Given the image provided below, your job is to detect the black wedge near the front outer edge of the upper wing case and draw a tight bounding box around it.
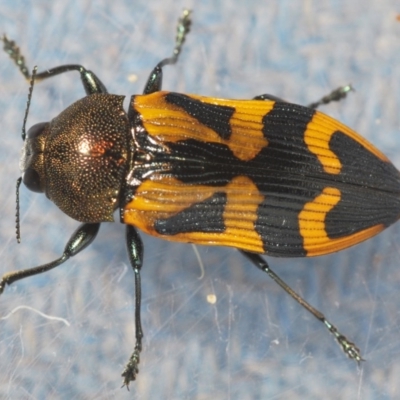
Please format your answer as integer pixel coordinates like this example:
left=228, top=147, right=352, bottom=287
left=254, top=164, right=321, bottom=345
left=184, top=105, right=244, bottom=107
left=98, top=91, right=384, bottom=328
left=165, top=92, right=235, bottom=140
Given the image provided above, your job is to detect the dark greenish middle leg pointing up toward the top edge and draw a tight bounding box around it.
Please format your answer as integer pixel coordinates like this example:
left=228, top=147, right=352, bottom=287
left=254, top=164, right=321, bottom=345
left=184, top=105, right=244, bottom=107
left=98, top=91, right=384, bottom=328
left=143, top=10, right=192, bottom=94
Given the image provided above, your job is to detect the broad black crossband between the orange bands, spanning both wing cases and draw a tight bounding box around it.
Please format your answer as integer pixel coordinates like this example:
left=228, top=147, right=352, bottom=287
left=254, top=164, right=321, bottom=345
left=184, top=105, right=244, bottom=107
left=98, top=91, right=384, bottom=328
left=254, top=102, right=318, bottom=257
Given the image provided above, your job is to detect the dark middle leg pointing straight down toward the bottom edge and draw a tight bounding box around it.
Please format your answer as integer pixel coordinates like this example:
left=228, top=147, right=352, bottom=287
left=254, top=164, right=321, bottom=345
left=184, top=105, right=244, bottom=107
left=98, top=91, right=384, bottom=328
left=121, top=225, right=143, bottom=389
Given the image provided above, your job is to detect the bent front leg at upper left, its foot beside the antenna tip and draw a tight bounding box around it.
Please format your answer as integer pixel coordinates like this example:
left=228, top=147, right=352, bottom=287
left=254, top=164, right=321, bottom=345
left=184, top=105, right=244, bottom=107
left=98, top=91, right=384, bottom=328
left=1, top=35, right=107, bottom=94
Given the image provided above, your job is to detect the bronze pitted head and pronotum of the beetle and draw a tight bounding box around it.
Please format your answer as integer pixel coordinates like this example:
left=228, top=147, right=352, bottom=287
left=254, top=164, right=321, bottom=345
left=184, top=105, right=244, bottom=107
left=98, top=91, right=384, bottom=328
left=20, top=94, right=130, bottom=222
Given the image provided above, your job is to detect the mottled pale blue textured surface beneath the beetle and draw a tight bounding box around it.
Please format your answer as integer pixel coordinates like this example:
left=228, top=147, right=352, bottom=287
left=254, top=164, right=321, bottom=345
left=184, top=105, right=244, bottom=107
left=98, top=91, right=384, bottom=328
left=0, top=0, right=400, bottom=400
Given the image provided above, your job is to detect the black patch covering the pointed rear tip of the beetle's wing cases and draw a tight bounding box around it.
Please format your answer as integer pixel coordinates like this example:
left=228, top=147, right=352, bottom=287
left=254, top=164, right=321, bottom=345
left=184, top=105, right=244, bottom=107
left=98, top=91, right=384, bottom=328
left=325, top=131, right=400, bottom=238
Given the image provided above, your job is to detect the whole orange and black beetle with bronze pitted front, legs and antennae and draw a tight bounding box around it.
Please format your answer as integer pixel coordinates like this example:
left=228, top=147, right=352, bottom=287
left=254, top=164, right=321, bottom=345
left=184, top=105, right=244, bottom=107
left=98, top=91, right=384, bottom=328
left=0, top=10, right=400, bottom=388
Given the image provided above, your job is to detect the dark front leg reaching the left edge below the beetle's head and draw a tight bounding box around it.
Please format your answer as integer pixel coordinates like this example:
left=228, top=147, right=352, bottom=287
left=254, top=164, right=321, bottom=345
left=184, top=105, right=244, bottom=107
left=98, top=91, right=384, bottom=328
left=0, top=224, right=100, bottom=294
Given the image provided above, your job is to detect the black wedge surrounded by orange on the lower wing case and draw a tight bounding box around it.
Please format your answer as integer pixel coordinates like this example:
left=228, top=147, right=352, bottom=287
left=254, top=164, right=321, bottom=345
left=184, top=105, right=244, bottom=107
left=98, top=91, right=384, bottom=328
left=154, top=192, right=227, bottom=235
